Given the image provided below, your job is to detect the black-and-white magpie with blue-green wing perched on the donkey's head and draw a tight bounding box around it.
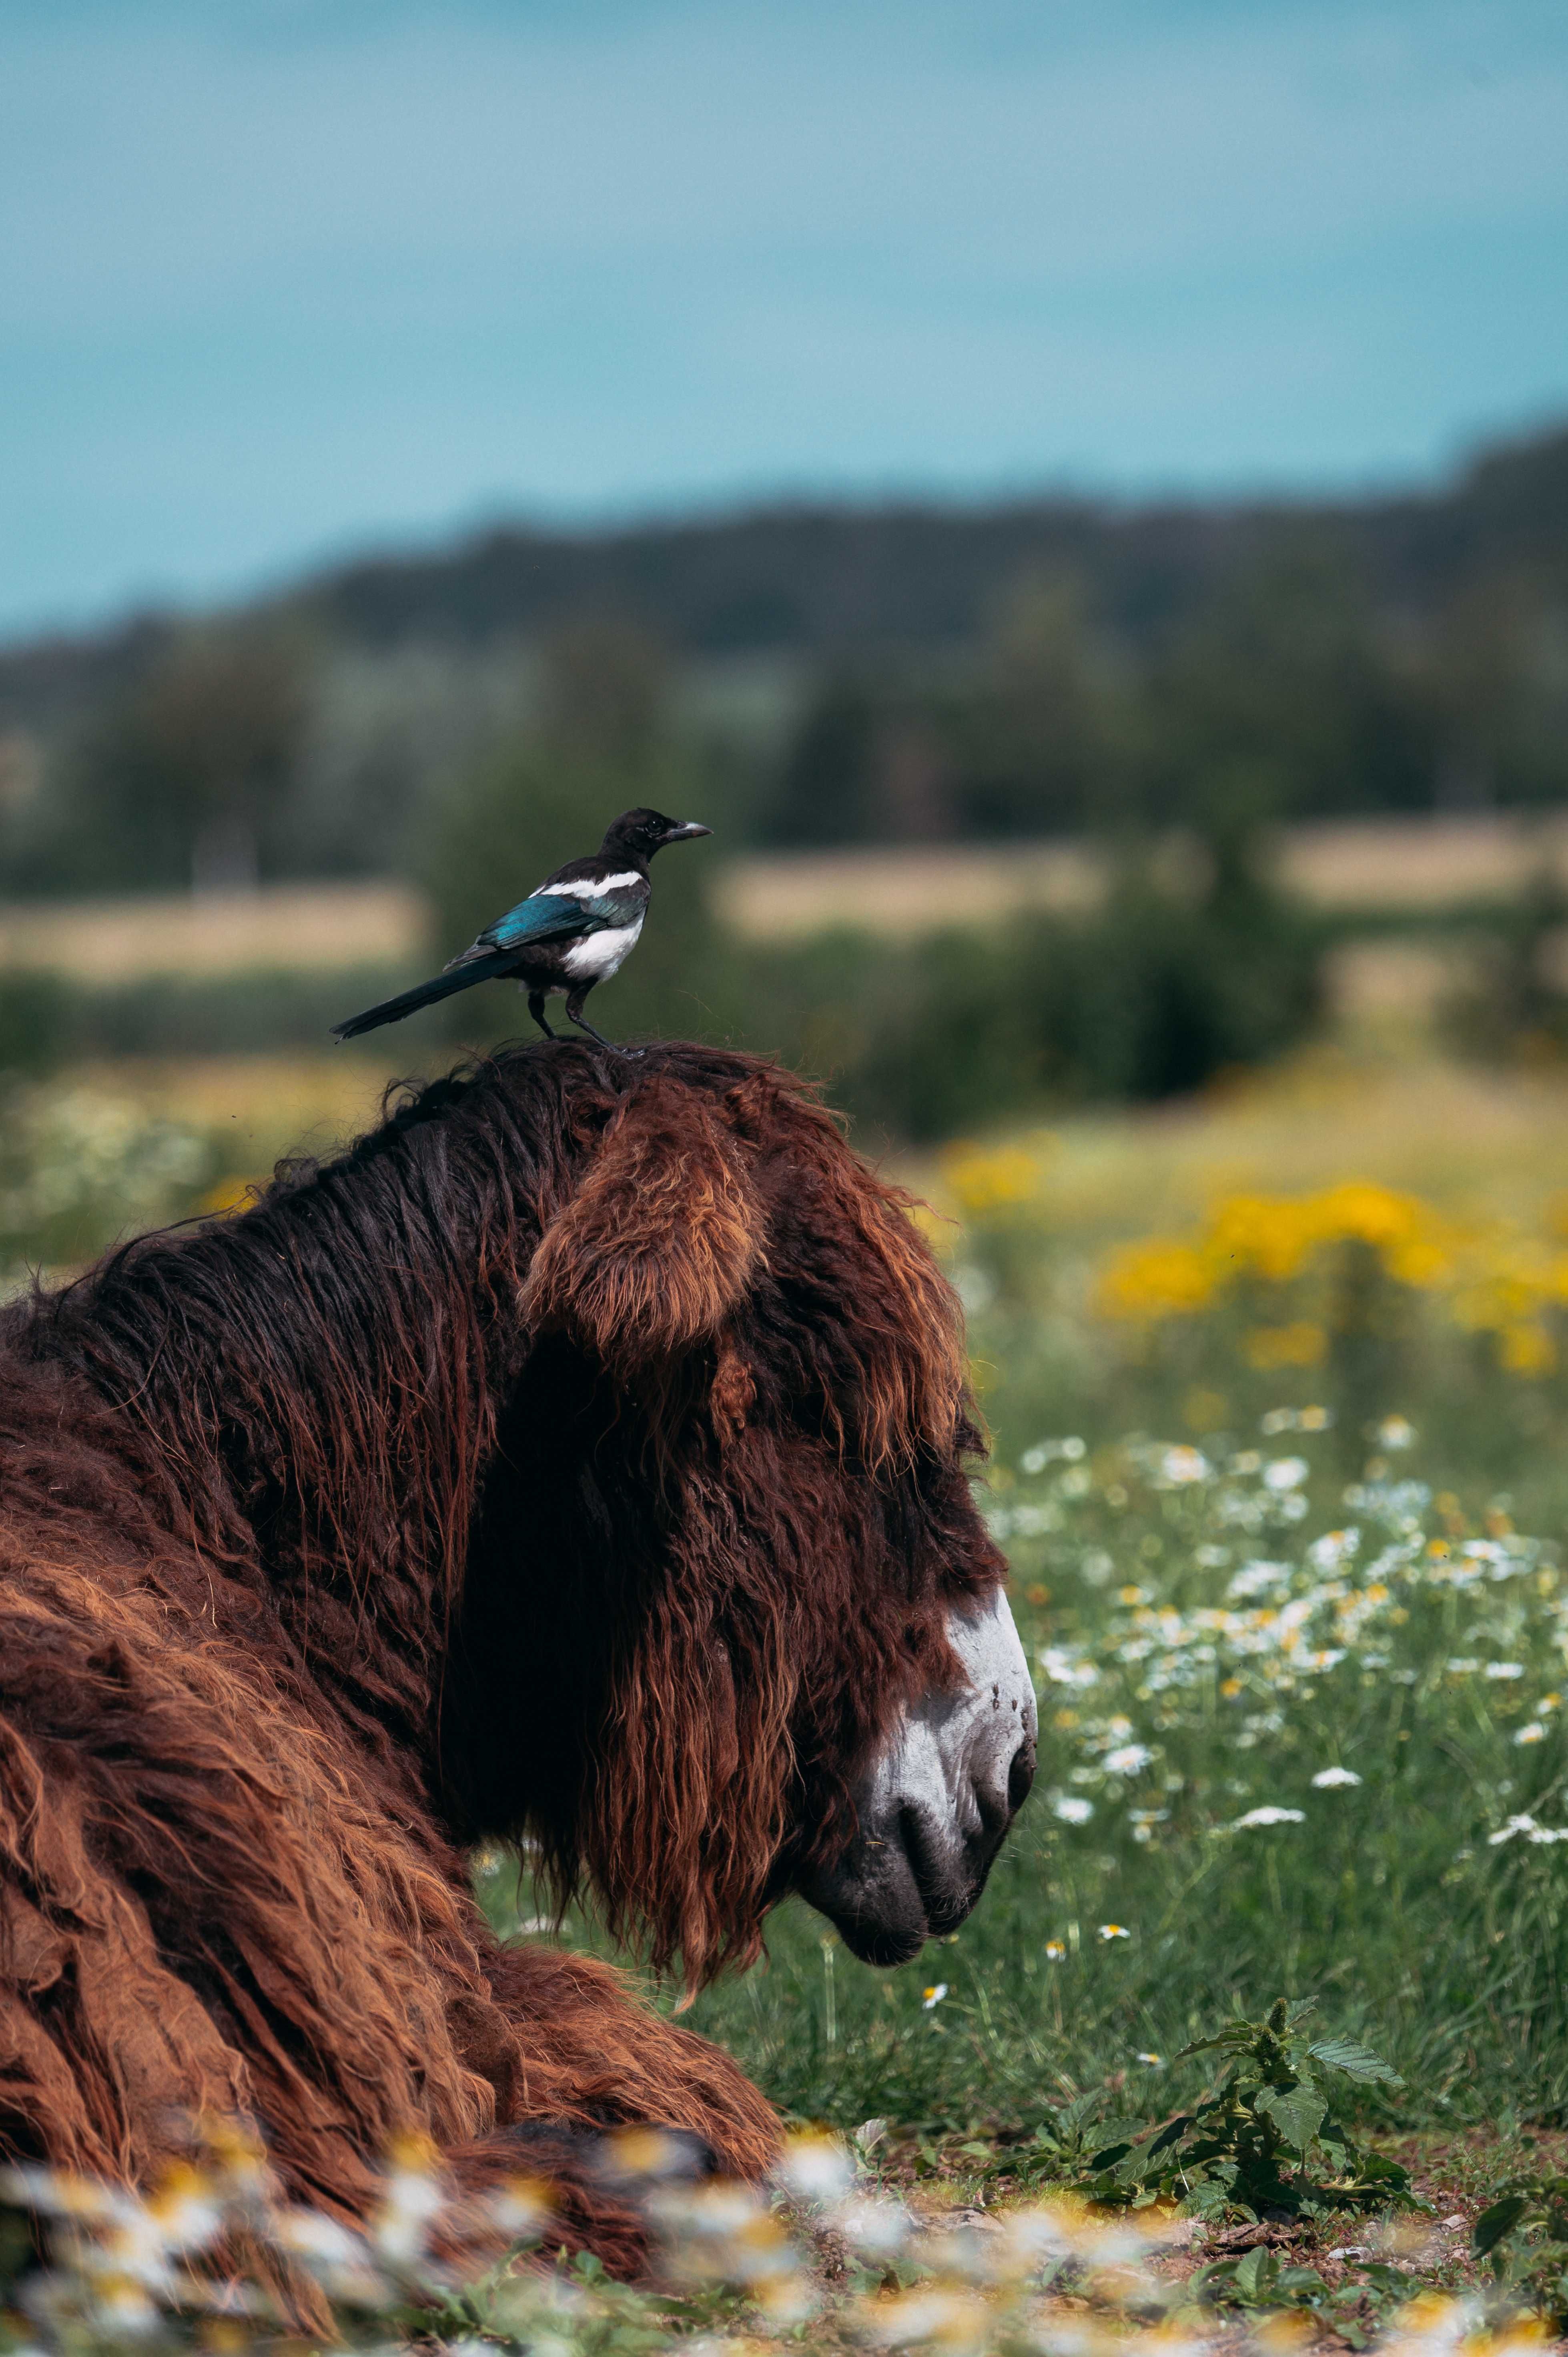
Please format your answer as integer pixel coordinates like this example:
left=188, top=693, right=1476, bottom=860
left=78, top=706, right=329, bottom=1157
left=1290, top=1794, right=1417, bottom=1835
left=333, top=811, right=712, bottom=1047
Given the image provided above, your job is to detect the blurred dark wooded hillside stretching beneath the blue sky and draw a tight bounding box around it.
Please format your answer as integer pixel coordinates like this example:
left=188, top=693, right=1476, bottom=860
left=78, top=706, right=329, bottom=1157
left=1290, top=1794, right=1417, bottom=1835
left=0, top=429, right=1568, bottom=898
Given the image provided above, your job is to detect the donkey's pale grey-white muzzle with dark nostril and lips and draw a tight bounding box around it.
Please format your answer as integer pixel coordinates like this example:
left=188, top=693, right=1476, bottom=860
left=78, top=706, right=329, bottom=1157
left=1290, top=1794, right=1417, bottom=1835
left=802, top=1589, right=1037, bottom=1964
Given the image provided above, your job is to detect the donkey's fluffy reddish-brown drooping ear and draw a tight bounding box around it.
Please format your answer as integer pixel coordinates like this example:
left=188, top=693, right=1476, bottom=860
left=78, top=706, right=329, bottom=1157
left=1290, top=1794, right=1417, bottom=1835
left=523, top=1075, right=764, bottom=1376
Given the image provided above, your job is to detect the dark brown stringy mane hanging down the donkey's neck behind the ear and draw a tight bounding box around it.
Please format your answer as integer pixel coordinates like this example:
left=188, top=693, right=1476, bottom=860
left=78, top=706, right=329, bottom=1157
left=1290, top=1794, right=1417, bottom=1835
left=0, top=1042, right=768, bottom=1763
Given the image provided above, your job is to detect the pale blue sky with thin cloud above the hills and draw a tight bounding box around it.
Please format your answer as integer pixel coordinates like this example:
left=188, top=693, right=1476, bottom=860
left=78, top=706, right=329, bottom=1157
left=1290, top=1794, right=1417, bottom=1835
left=0, top=0, right=1568, bottom=634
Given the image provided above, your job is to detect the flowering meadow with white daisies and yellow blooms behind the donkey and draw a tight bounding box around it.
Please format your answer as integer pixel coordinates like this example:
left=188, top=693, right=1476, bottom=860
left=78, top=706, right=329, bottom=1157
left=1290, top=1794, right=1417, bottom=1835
left=15, top=1032, right=1568, bottom=2345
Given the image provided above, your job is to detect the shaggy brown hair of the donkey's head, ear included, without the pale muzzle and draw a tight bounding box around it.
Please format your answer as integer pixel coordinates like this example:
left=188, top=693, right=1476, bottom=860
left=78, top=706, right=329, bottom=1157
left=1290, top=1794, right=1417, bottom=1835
left=511, top=1063, right=974, bottom=1985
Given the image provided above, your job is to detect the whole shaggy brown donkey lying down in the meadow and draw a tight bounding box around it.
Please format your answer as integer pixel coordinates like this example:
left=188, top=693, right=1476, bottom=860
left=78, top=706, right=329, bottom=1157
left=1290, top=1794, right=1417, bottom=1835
left=0, top=1044, right=1033, bottom=2270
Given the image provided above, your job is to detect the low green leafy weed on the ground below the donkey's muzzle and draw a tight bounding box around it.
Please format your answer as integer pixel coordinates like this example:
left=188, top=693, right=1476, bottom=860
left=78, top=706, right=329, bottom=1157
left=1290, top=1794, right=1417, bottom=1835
left=1028, top=1999, right=1415, bottom=2218
